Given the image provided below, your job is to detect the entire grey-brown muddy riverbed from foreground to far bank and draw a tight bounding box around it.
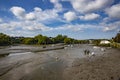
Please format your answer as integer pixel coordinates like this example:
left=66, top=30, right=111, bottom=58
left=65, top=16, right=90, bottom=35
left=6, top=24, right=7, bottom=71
left=0, top=45, right=120, bottom=80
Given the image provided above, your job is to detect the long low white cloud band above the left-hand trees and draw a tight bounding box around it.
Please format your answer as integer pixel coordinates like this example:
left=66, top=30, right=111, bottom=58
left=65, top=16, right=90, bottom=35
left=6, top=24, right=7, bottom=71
left=0, top=21, right=51, bottom=32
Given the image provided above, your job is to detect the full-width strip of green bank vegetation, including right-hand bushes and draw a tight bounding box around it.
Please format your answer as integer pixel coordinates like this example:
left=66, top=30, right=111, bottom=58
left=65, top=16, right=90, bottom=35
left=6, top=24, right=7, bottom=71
left=0, top=32, right=120, bottom=47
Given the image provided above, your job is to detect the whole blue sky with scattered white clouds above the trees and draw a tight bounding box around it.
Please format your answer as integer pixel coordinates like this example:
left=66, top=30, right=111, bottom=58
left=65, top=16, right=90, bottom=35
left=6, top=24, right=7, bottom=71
left=0, top=0, right=120, bottom=39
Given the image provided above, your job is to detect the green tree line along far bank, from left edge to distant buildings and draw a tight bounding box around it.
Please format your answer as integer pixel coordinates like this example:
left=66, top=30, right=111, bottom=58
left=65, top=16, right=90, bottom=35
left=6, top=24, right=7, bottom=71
left=0, top=33, right=89, bottom=46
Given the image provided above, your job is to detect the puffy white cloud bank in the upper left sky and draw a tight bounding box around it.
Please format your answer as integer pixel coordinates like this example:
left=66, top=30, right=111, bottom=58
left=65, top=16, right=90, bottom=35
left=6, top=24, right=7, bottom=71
left=10, top=6, right=58, bottom=21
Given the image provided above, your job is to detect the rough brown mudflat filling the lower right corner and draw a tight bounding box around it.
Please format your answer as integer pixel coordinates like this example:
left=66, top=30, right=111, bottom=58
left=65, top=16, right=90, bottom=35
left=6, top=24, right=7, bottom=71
left=64, top=49, right=120, bottom=80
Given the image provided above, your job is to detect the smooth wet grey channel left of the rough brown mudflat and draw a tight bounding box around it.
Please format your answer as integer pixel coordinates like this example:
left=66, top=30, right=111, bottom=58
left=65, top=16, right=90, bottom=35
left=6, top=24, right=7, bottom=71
left=0, top=45, right=103, bottom=80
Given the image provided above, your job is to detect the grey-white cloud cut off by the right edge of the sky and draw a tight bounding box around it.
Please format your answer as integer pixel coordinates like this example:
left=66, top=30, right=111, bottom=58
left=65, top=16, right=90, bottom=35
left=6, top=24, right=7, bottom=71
left=105, top=4, right=120, bottom=19
